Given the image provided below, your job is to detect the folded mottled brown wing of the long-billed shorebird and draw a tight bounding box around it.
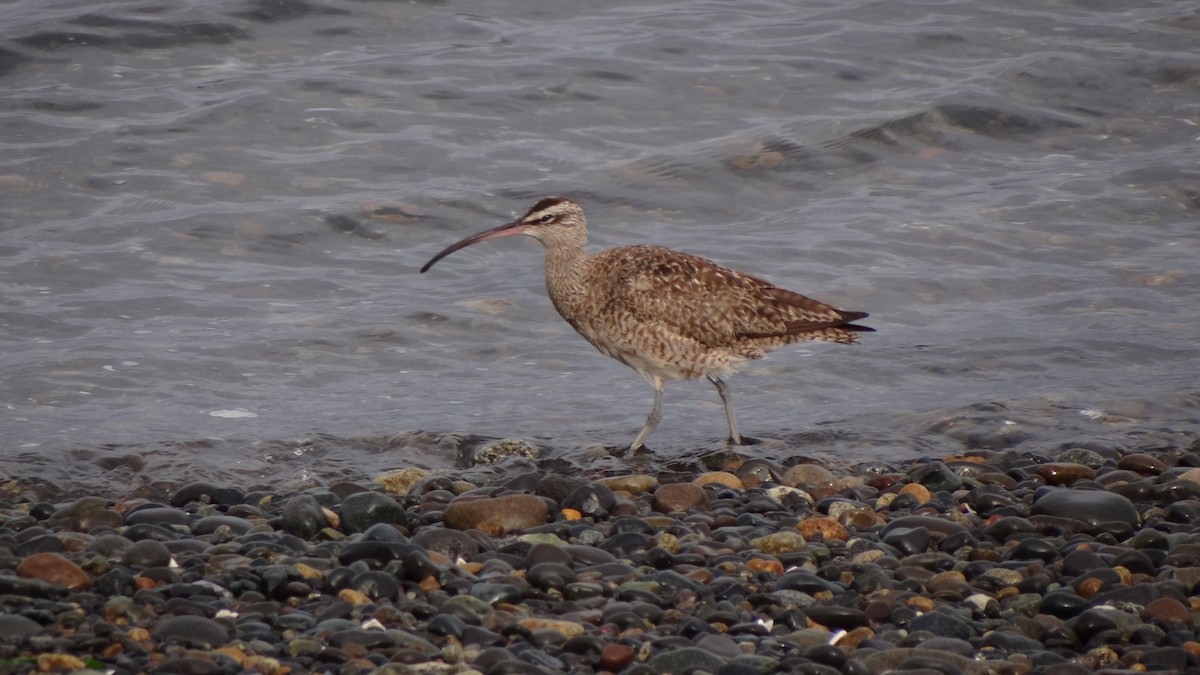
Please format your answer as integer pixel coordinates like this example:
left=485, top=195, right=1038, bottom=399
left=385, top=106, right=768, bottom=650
left=598, top=246, right=865, bottom=347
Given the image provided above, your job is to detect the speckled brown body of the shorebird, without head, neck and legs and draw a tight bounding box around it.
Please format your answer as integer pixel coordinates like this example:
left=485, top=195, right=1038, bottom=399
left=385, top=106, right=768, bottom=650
left=546, top=246, right=865, bottom=380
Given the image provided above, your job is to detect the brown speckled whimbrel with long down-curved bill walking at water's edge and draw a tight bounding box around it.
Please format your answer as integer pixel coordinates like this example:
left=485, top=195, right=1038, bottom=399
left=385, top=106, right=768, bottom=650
left=421, top=197, right=875, bottom=456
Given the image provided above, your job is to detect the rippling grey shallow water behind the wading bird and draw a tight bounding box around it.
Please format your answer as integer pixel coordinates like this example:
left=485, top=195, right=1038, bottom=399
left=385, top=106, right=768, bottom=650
left=0, top=0, right=1200, bottom=494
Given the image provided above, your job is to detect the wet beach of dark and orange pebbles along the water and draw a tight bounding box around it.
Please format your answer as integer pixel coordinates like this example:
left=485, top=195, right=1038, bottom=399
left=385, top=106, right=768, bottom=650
left=7, top=442, right=1200, bottom=675
